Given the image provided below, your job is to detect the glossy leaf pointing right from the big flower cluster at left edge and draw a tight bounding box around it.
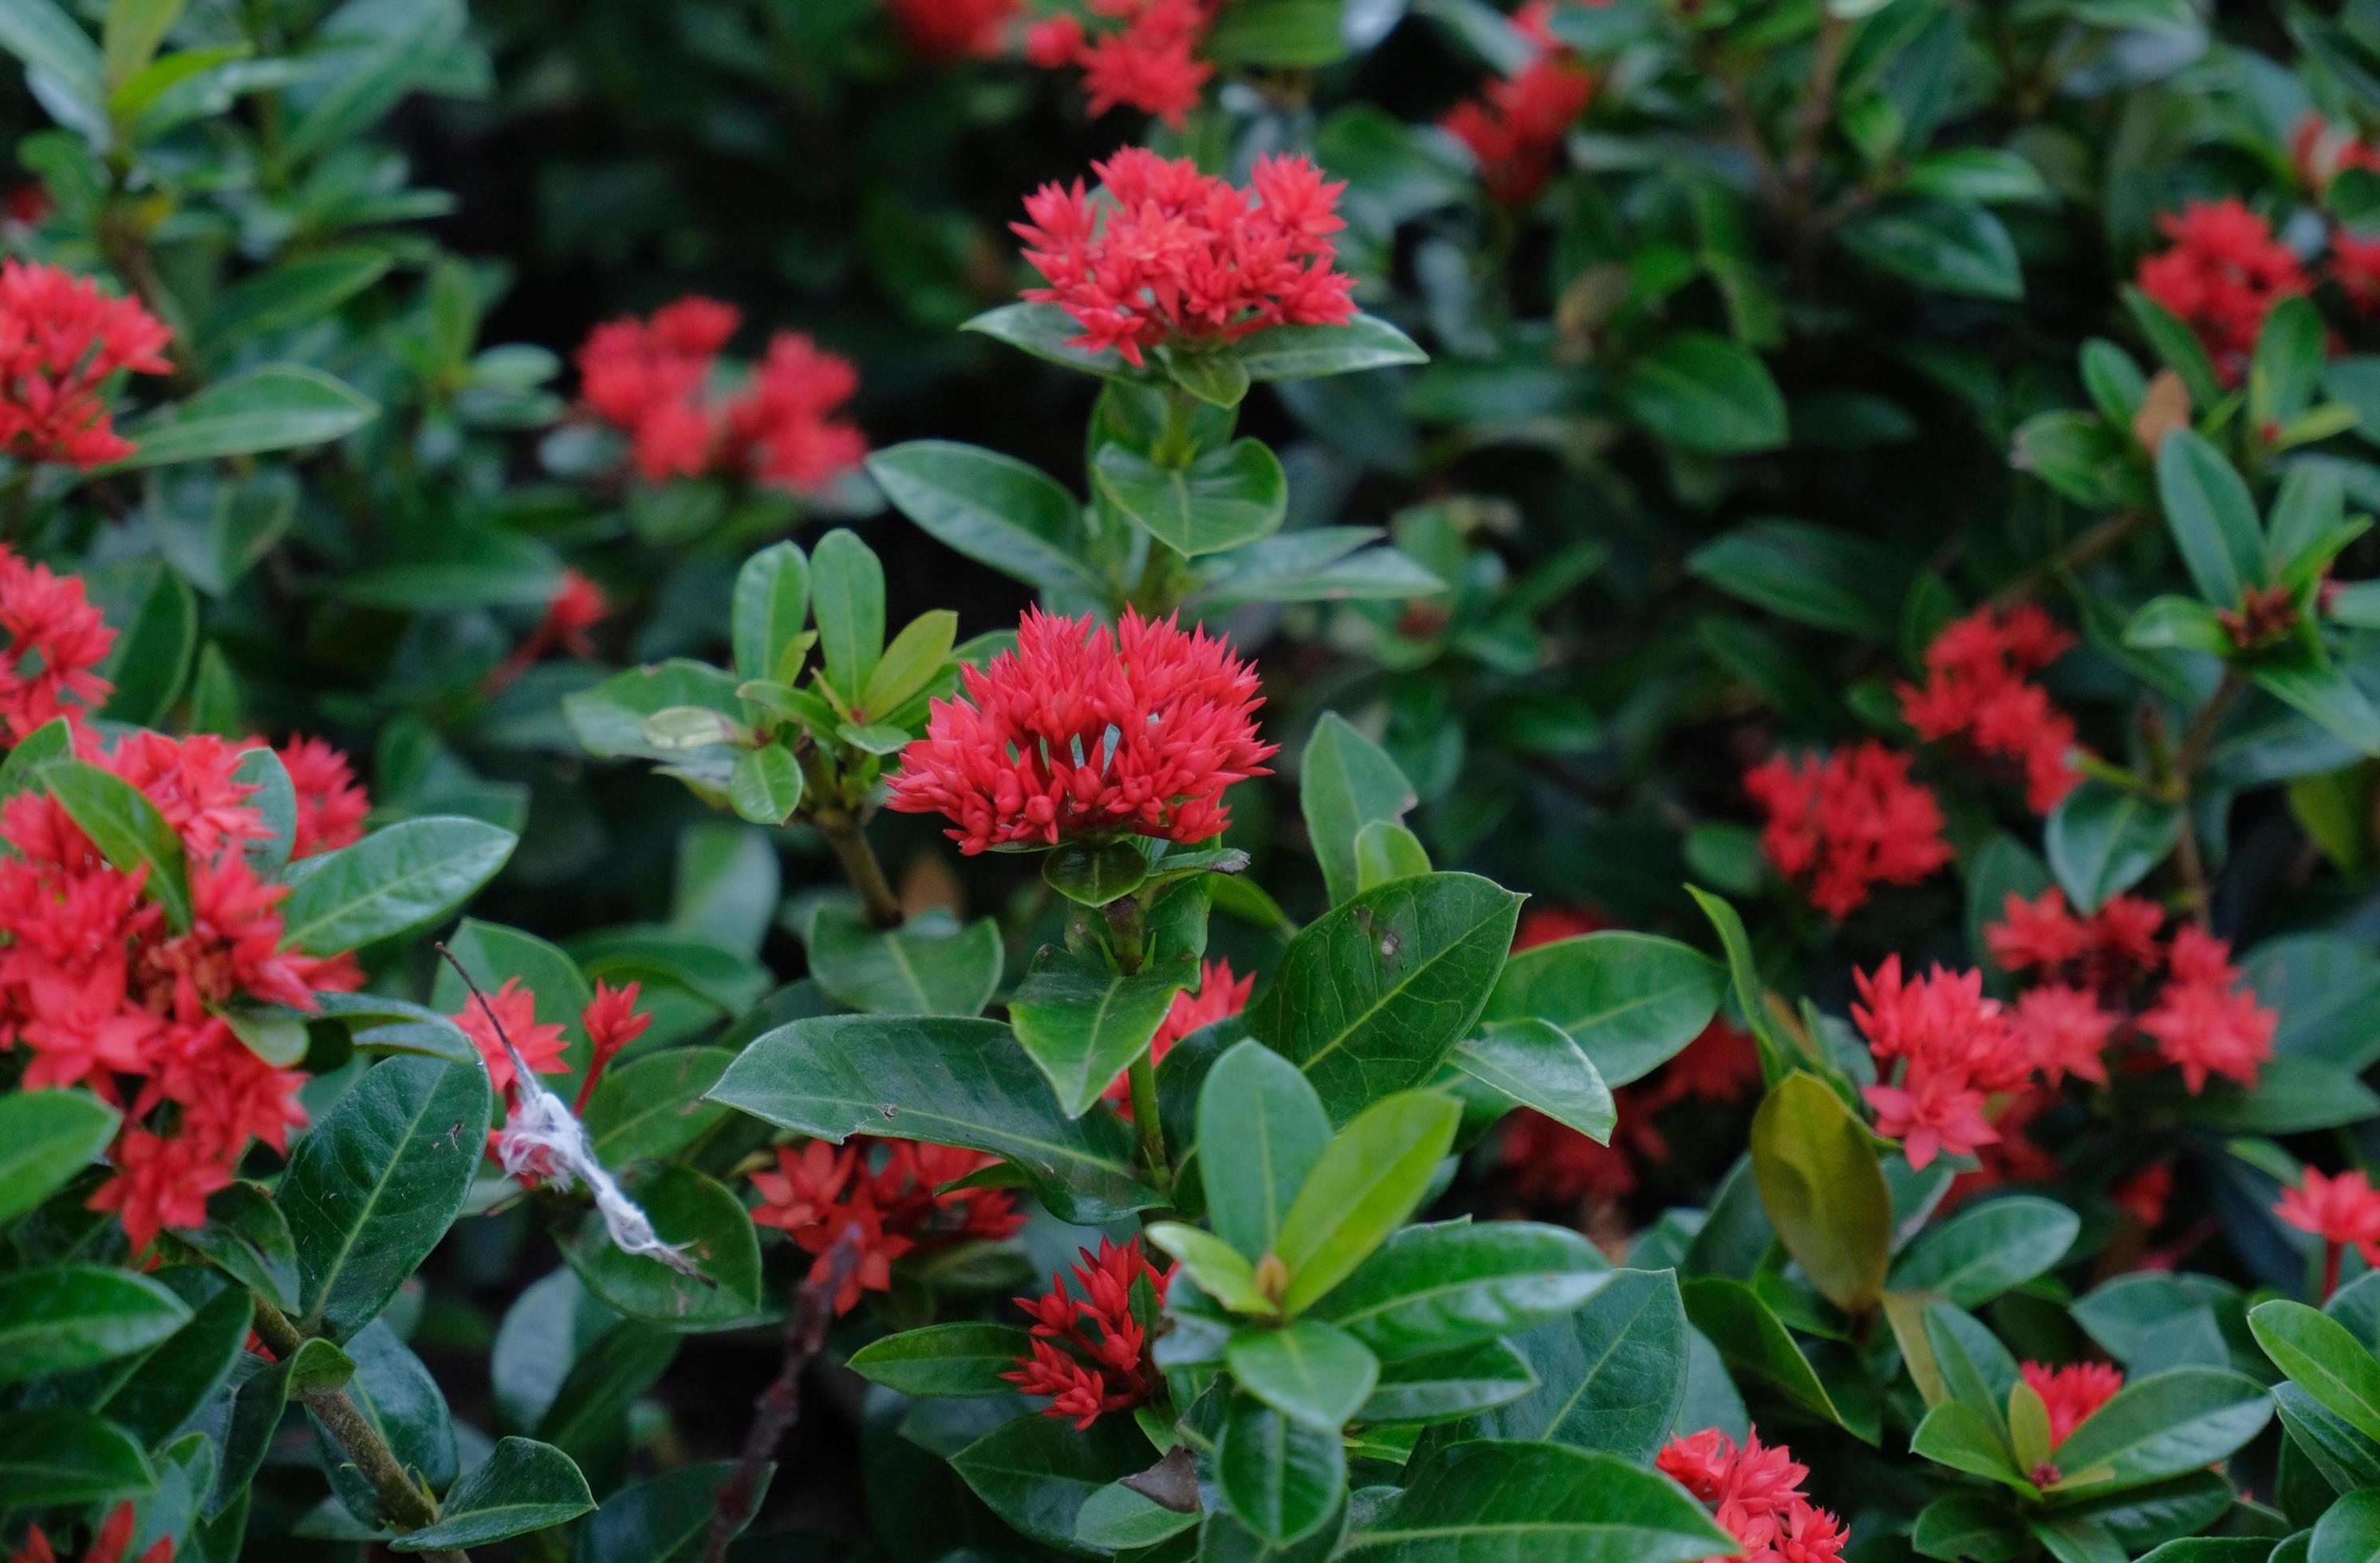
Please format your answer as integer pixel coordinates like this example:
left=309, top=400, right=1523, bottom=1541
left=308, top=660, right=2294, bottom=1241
left=281, top=816, right=519, bottom=954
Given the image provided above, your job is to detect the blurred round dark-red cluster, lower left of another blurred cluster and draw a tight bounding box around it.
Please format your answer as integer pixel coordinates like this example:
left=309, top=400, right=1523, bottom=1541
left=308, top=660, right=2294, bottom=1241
left=1744, top=738, right=1949, bottom=919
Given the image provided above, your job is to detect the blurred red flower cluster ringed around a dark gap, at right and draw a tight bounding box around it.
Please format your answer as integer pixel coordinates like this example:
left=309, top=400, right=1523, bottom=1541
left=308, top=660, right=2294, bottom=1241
left=1983, top=890, right=2280, bottom=1092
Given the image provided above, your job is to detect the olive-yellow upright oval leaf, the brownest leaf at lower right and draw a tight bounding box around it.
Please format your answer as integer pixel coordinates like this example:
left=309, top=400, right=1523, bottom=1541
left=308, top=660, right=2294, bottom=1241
left=1752, top=1070, right=1892, bottom=1313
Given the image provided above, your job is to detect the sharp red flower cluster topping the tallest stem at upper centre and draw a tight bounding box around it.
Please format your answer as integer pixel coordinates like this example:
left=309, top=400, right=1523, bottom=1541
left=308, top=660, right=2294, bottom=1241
left=1009, top=148, right=1354, bottom=364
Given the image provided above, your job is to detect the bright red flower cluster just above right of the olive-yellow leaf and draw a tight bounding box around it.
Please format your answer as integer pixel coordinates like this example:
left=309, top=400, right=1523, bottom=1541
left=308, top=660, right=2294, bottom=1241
left=1852, top=954, right=2032, bottom=1168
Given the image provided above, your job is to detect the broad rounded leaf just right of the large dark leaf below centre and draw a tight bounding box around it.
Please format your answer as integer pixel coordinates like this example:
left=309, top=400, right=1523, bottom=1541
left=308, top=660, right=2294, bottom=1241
left=1485, top=932, right=1728, bottom=1087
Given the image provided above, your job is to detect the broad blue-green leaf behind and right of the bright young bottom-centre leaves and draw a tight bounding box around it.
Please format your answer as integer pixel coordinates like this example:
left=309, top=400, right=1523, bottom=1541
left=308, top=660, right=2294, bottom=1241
left=1447, top=1266, right=1702, bottom=1466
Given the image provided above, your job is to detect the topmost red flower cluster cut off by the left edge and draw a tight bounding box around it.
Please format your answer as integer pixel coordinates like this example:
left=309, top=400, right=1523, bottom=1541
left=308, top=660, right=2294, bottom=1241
left=0, top=259, right=174, bottom=469
